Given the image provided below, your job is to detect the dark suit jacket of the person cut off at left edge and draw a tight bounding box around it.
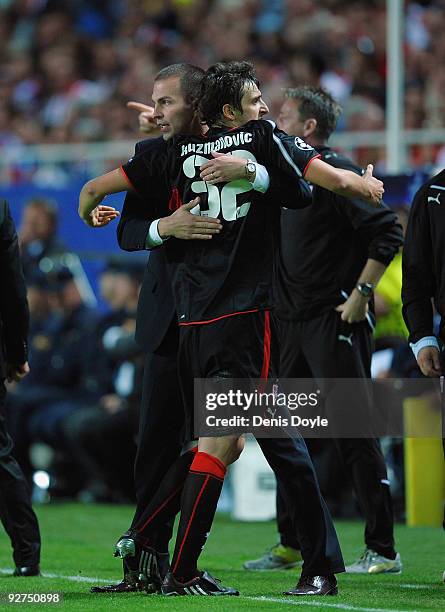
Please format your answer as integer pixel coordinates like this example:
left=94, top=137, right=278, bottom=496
left=0, top=200, right=29, bottom=378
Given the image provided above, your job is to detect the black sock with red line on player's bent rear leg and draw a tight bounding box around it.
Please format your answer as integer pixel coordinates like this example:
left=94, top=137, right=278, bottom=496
left=131, top=447, right=197, bottom=552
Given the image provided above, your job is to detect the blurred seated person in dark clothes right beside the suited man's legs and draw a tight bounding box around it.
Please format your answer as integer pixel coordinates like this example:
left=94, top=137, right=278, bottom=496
left=62, top=262, right=143, bottom=501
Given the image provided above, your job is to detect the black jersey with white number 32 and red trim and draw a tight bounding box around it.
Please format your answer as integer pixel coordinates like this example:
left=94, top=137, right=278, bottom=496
left=123, top=121, right=318, bottom=325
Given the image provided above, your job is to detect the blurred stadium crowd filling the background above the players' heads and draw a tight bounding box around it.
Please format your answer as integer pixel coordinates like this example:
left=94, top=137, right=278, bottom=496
left=0, top=0, right=445, bottom=170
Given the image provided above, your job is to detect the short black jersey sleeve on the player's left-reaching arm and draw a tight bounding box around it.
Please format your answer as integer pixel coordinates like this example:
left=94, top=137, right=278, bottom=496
left=120, top=150, right=168, bottom=200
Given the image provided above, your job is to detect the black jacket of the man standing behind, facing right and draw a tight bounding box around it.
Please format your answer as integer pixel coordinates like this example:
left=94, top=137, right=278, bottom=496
left=275, top=147, right=403, bottom=320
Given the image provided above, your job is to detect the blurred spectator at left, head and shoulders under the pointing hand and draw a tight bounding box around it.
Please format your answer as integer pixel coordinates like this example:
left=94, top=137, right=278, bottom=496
left=18, top=198, right=66, bottom=280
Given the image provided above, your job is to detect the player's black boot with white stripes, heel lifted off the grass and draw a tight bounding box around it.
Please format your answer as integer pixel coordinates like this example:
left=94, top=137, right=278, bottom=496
left=114, top=534, right=170, bottom=593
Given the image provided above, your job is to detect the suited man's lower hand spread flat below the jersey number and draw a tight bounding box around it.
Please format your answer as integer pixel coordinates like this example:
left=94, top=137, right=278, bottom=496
left=158, top=197, right=222, bottom=240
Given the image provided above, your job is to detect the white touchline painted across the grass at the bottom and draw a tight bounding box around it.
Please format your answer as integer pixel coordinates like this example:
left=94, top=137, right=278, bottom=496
left=0, top=567, right=422, bottom=612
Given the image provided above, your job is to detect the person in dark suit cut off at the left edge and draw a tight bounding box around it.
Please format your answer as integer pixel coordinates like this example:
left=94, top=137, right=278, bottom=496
left=0, top=200, right=40, bottom=576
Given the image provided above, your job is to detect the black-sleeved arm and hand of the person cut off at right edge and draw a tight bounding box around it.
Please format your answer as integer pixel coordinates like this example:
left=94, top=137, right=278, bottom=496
left=402, top=187, right=441, bottom=377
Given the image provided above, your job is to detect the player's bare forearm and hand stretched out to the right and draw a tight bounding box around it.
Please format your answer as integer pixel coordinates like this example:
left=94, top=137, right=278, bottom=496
left=304, top=159, right=385, bottom=206
